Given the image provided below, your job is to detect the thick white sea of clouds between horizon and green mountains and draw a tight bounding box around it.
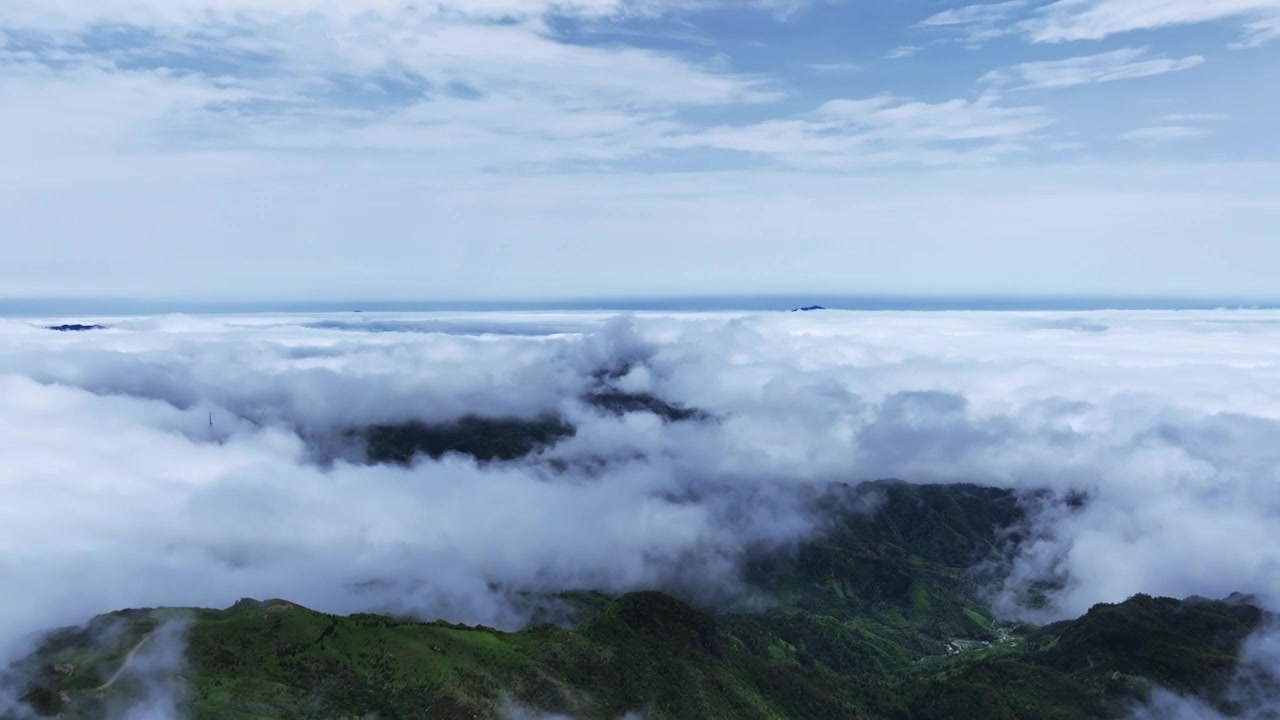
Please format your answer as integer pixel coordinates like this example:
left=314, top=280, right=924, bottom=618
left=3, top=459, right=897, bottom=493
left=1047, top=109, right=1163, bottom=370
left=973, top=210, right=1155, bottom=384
left=0, top=310, right=1280, bottom=681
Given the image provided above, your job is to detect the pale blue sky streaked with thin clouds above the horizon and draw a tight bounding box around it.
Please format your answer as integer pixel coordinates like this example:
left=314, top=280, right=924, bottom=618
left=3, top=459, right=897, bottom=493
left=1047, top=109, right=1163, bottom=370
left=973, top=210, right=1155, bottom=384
left=0, top=0, right=1280, bottom=300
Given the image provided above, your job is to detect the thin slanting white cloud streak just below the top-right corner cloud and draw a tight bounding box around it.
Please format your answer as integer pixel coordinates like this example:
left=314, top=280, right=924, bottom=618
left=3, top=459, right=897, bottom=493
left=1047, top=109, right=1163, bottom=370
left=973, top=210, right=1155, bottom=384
left=982, top=47, right=1204, bottom=90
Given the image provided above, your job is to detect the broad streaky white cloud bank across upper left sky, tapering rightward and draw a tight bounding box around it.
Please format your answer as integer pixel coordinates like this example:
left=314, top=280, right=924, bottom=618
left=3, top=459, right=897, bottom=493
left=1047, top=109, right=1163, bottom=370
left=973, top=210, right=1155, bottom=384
left=0, top=0, right=778, bottom=172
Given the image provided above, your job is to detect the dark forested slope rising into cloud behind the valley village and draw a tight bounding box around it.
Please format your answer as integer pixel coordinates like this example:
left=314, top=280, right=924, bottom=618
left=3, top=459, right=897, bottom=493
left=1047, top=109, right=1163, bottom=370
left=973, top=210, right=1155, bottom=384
left=746, top=482, right=1024, bottom=645
